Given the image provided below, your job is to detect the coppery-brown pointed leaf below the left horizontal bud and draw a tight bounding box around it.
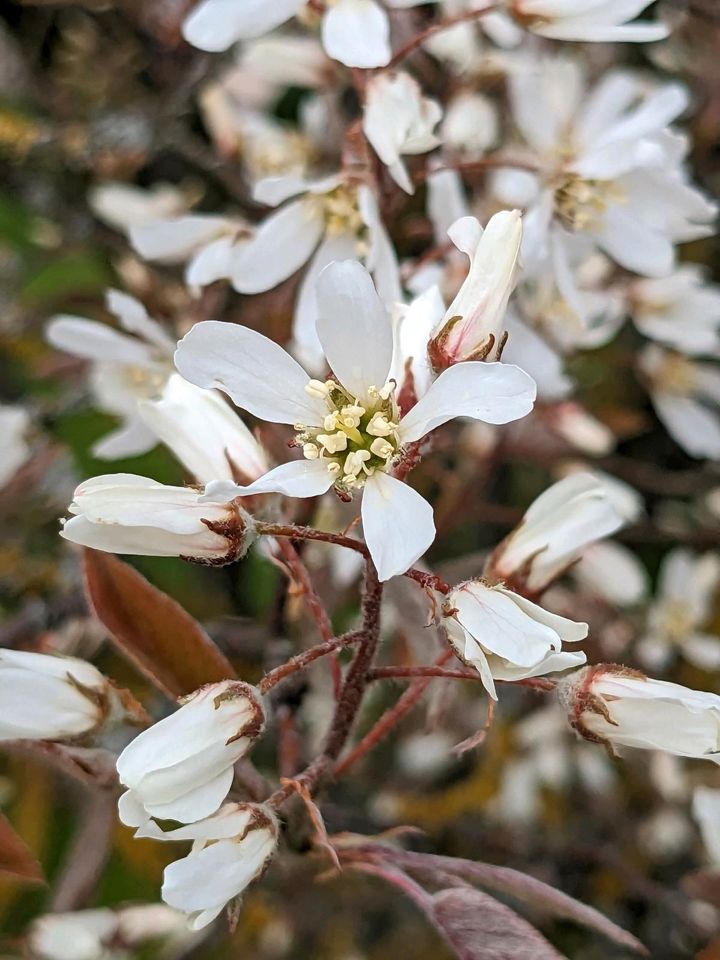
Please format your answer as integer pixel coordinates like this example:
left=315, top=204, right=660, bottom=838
left=84, top=550, right=236, bottom=698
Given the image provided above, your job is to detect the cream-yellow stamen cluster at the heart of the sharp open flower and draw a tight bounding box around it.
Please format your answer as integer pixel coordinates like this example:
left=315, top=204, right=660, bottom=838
left=295, top=380, right=400, bottom=490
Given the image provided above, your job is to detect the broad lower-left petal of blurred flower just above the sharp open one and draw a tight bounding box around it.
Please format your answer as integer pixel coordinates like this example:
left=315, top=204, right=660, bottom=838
left=232, top=197, right=325, bottom=293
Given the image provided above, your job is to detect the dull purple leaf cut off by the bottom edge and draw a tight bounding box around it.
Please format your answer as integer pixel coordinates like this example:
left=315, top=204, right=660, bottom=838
left=431, top=887, right=563, bottom=960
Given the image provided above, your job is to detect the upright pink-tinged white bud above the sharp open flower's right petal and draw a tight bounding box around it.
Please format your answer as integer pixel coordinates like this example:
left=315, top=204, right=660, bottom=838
left=428, top=210, right=522, bottom=371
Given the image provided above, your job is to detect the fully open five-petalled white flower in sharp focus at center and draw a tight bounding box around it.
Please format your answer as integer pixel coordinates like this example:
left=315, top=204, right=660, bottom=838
left=175, top=261, right=535, bottom=580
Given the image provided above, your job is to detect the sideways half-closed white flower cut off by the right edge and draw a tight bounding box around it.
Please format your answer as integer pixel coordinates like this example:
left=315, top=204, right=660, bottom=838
left=558, top=664, right=720, bottom=763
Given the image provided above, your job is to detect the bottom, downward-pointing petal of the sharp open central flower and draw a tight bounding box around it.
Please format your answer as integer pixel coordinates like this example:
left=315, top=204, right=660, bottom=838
left=362, top=472, right=435, bottom=580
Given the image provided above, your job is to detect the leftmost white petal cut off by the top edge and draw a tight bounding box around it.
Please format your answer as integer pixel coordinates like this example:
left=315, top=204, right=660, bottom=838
left=183, top=0, right=305, bottom=53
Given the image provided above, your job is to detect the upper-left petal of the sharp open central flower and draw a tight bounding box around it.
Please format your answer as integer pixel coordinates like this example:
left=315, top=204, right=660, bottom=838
left=175, top=320, right=326, bottom=426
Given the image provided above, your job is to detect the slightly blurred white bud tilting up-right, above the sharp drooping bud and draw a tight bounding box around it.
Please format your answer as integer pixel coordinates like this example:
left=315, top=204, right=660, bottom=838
left=490, top=473, right=625, bottom=592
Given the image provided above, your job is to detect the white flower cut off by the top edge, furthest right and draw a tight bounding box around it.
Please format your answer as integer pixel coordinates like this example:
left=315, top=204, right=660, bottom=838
left=510, top=0, right=670, bottom=43
